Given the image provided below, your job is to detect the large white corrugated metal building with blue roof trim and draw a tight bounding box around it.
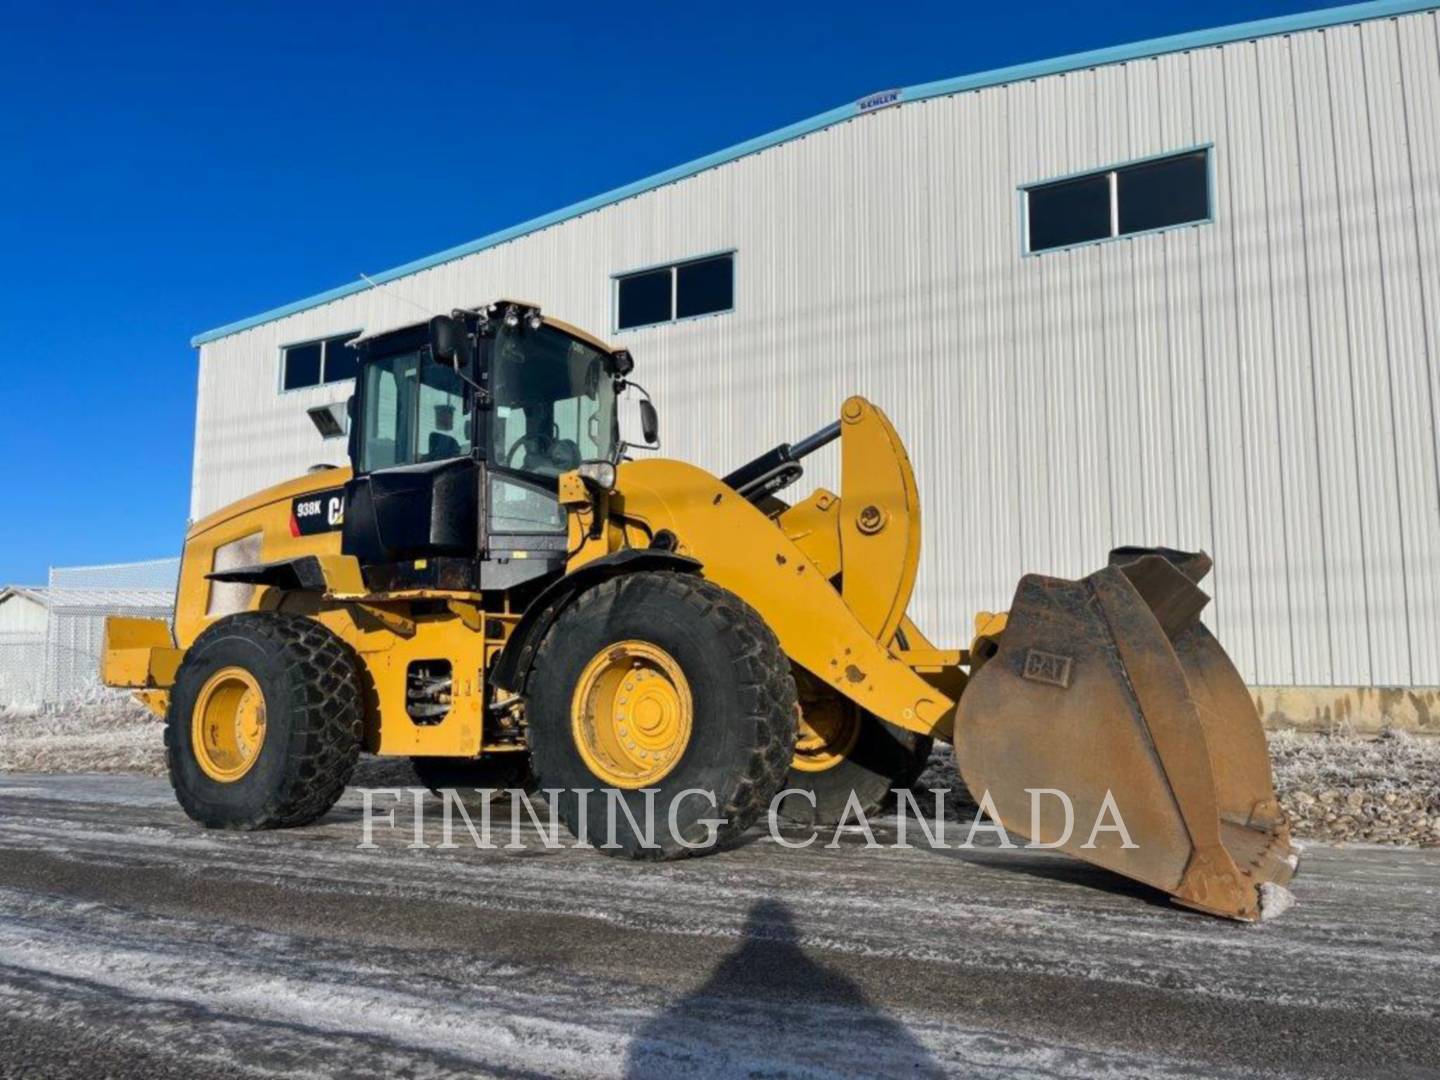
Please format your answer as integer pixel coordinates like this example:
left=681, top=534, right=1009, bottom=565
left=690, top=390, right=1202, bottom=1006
left=192, top=3, right=1440, bottom=700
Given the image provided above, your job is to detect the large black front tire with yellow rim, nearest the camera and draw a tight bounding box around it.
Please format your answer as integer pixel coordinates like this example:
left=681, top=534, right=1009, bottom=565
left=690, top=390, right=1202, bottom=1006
left=526, top=572, right=798, bottom=860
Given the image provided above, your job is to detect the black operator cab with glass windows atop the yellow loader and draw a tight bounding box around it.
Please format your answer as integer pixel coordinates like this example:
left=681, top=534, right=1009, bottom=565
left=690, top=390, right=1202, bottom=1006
left=341, top=302, right=629, bottom=590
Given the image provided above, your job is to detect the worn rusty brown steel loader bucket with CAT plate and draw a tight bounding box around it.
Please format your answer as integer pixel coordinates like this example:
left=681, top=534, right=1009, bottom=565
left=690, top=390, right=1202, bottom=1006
left=955, top=549, right=1297, bottom=920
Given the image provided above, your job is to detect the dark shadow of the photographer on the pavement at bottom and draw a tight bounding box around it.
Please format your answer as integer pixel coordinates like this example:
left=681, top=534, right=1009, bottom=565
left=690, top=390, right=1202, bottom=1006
left=625, top=900, right=943, bottom=1080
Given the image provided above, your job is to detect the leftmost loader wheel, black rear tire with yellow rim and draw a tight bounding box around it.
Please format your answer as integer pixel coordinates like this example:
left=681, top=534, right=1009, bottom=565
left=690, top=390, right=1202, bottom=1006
left=166, top=612, right=364, bottom=829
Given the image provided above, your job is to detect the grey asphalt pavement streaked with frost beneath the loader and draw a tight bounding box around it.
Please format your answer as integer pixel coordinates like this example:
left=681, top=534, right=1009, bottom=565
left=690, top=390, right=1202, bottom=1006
left=0, top=775, right=1440, bottom=1080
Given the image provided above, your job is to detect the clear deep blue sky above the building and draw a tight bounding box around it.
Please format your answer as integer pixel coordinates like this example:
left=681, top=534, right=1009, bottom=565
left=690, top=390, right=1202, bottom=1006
left=0, top=0, right=1347, bottom=583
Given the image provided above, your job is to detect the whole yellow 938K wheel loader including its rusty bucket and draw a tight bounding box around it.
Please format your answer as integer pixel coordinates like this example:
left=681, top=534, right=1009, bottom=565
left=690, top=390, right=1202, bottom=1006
left=102, top=301, right=1296, bottom=919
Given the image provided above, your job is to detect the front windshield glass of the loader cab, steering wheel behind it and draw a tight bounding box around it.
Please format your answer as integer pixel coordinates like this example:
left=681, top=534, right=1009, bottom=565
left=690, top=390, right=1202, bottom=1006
left=490, top=323, right=616, bottom=477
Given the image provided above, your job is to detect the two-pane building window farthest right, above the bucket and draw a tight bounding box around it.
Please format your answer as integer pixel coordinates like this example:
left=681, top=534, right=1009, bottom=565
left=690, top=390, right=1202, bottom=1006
left=1022, top=147, right=1211, bottom=253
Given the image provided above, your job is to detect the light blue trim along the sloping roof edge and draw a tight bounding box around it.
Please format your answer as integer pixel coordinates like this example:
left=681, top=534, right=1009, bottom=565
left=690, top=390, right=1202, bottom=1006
left=190, top=0, right=1440, bottom=346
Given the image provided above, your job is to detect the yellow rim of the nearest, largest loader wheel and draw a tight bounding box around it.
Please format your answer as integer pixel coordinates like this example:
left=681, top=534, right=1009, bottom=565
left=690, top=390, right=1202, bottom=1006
left=570, top=641, right=696, bottom=789
